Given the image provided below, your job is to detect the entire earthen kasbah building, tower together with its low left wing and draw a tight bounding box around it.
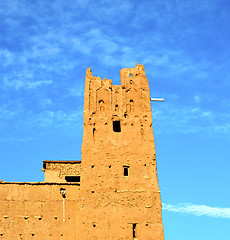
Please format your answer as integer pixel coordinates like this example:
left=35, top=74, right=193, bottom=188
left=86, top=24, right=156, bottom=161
left=0, top=64, right=164, bottom=240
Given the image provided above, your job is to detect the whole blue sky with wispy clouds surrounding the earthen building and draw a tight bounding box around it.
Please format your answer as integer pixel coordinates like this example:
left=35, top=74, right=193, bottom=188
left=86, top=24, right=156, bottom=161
left=0, top=0, right=230, bottom=240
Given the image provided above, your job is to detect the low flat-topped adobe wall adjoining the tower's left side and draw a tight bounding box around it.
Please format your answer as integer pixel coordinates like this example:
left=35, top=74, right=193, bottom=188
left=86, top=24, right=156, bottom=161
left=0, top=183, right=80, bottom=240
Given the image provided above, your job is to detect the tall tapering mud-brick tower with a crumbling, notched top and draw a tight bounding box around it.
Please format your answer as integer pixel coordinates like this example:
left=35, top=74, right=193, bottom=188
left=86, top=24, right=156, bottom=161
left=78, top=64, right=164, bottom=240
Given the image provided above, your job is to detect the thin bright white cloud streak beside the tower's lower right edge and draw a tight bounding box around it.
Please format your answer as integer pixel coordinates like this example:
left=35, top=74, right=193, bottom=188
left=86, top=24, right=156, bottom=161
left=162, top=203, right=230, bottom=219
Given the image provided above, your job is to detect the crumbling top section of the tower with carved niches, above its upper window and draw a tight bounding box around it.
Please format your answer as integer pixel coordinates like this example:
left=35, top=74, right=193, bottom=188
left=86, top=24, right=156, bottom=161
left=84, top=64, right=151, bottom=122
